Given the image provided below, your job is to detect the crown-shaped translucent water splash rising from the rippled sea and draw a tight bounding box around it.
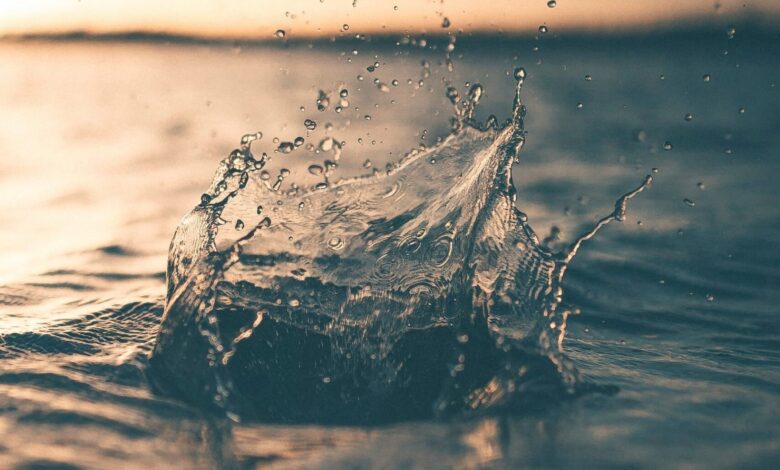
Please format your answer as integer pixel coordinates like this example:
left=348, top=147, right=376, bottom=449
left=151, top=68, right=651, bottom=422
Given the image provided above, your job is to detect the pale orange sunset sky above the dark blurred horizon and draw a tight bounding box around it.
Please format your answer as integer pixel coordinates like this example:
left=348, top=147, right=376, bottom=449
left=0, top=0, right=780, bottom=39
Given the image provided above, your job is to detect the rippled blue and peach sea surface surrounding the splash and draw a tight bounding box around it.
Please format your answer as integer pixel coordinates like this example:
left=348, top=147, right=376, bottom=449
left=0, top=28, right=780, bottom=468
